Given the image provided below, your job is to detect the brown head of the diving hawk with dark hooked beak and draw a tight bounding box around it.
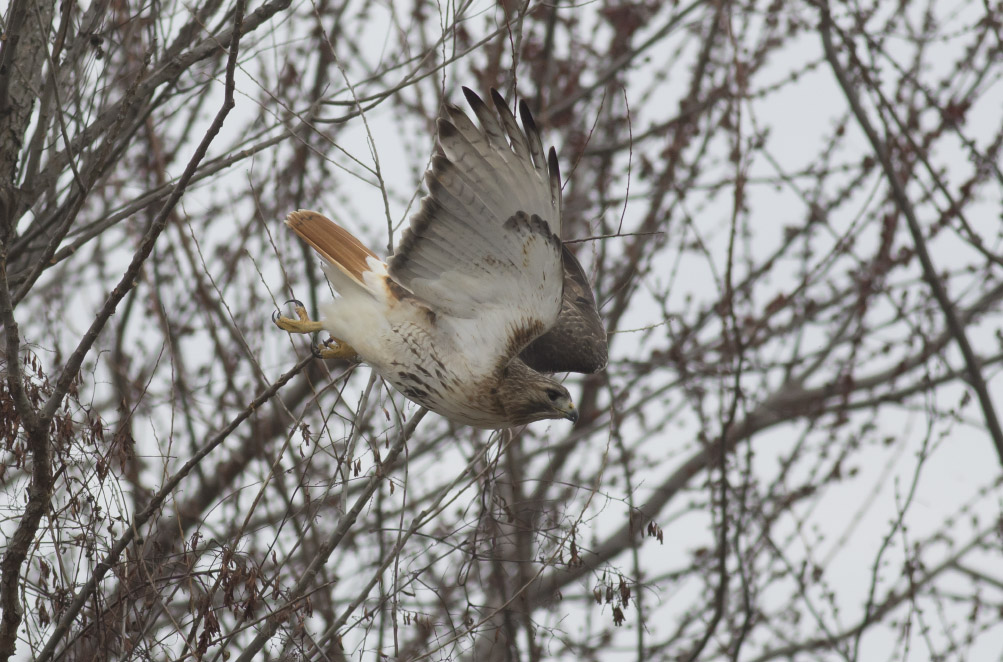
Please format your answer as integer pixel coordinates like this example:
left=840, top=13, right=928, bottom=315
left=498, top=359, right=578, bottom=425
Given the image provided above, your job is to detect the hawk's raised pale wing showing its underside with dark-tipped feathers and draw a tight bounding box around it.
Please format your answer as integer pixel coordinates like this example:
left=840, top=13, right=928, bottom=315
left=387, top=88, right=565, bottom=373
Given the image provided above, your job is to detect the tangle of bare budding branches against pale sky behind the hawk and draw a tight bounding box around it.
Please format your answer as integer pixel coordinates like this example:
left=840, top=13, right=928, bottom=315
left=0, top=0, right=1003, bottom=661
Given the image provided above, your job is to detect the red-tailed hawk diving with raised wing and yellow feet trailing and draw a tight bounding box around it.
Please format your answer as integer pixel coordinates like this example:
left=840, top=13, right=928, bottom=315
left=276, top=87, right=607, bottom=428
